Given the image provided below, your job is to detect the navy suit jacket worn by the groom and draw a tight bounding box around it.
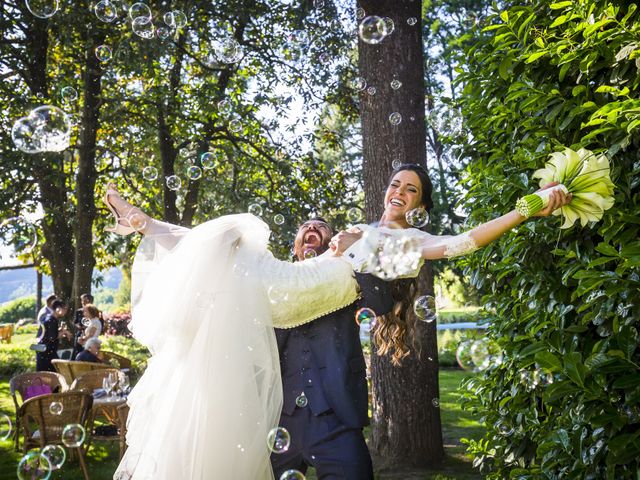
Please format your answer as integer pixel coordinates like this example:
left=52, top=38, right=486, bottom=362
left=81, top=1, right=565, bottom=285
left=275, top=273, right=393, bottom=428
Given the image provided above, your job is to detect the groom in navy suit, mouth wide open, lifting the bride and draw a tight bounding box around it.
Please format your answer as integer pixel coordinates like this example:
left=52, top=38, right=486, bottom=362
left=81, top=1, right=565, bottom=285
left=271, top=218, right=393, bottom=480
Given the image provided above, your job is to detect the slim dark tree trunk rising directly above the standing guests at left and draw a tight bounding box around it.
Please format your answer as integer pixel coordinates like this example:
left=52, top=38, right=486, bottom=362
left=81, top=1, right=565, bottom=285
left=72, top=31, right=103, bottom=305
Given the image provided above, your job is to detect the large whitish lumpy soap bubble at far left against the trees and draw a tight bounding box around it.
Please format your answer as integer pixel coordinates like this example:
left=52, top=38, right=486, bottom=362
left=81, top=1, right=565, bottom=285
left=11, top=105, right=71, bottom=153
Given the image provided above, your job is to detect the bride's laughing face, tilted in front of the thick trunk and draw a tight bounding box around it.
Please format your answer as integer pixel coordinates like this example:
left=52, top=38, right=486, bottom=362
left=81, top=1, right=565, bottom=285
left=384, top=170, right=422, bottom=228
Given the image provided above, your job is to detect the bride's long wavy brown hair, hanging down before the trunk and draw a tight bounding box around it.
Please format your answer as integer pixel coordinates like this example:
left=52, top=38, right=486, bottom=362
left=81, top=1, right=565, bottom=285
left=373, top=163, right=433, bottom=366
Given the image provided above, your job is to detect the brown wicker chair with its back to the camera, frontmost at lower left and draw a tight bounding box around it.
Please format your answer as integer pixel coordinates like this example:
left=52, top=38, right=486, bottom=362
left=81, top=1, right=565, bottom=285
left=19, top=392, right=93, bottom=480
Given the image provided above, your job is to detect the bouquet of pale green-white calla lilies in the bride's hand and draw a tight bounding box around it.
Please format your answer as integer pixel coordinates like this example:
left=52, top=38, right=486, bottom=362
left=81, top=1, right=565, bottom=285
left=516, top=148, right=614, bottom=228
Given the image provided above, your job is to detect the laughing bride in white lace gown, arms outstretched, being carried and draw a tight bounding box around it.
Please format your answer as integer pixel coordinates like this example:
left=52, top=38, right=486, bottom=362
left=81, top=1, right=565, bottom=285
left=104, top=165, right=570, bottom=480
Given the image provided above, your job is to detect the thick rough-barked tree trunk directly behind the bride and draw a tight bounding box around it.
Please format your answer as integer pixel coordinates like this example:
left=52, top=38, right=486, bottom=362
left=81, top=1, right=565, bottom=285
left=359, top=0, right=444, bottom=467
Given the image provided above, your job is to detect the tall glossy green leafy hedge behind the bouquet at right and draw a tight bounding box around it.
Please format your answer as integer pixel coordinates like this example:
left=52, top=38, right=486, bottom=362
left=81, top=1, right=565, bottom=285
left=458, top=0, right=640, bottom=479
